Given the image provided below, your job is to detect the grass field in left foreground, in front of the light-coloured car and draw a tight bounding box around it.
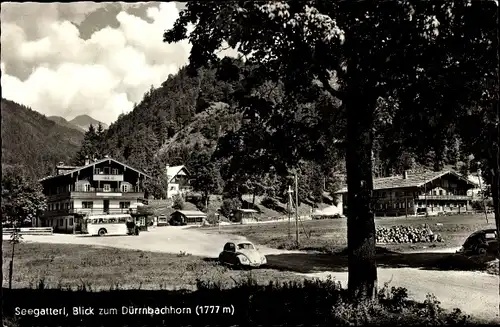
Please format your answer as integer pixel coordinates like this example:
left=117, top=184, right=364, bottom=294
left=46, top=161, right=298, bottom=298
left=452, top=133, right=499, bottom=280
left=3, top=241, right=301, bottom=290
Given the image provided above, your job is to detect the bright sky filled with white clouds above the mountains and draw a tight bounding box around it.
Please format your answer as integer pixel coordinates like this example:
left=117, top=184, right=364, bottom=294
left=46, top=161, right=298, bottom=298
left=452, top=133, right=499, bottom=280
left=0, top=2, right=197, bottom=125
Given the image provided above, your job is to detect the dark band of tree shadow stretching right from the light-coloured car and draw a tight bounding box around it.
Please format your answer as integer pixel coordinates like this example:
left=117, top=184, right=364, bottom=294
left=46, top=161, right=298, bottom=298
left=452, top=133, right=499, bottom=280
left=266, top=248, right=494, bottom=273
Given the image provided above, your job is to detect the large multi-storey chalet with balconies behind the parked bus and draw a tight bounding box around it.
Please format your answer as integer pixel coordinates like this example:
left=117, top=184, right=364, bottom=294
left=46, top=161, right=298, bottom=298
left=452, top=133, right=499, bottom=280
left=39, top=158, right=149, bottom=233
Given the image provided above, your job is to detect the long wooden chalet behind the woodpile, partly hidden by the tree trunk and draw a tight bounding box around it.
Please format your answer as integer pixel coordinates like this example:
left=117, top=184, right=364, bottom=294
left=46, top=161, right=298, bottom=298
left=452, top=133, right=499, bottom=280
left=337, top=170, right=478, bottom=216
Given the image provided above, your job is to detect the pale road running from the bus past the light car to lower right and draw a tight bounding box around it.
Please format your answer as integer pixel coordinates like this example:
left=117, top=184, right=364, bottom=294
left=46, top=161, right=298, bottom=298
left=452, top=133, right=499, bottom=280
left=23, top=227, right=500, bottom=320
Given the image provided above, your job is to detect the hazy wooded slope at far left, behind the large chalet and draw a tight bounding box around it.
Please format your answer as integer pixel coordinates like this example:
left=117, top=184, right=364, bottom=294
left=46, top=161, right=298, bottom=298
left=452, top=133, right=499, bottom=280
left=1, top=99, right=84, bottom=178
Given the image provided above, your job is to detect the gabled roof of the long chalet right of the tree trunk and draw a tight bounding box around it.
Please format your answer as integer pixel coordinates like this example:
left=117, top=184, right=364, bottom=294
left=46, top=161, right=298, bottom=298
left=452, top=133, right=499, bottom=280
left=335, top=170, right=478, bottom=193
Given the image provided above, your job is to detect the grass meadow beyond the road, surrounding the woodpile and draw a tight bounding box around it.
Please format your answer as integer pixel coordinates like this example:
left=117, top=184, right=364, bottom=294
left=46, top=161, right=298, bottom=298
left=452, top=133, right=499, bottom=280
left=200, top=214, right=495, bottom=252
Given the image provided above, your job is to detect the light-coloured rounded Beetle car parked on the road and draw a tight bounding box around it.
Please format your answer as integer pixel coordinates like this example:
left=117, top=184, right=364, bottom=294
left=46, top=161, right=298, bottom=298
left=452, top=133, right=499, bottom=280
left=219, top=242, right=267, bottom=268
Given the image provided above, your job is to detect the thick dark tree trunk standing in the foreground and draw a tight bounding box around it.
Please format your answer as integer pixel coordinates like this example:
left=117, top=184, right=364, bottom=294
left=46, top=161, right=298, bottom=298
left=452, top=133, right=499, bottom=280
left=345, top=94, right=377, bottom=300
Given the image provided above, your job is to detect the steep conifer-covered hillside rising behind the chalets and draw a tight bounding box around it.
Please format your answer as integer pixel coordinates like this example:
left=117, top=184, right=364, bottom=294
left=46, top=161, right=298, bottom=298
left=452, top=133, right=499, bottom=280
left=72, top=61, right=468, bottom=209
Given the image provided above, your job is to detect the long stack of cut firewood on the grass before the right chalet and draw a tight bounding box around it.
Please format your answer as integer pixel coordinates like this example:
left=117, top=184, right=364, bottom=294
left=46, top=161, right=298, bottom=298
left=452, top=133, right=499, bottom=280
left=376, top=226, right=443, bottom=244
